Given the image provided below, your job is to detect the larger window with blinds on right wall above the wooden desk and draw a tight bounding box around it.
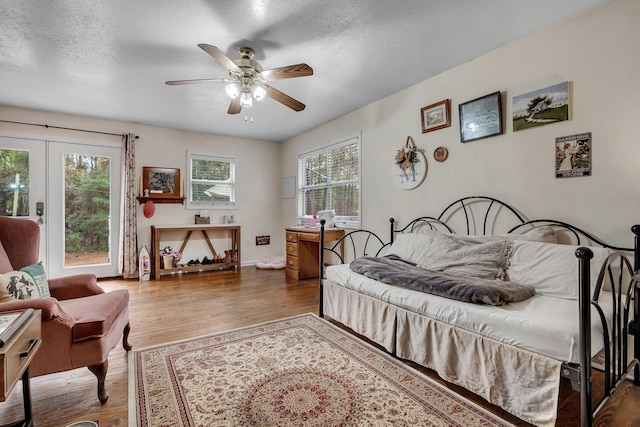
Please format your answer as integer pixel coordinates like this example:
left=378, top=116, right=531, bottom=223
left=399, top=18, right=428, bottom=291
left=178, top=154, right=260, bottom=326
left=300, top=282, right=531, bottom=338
left=298, top=137, right=360, bottom=228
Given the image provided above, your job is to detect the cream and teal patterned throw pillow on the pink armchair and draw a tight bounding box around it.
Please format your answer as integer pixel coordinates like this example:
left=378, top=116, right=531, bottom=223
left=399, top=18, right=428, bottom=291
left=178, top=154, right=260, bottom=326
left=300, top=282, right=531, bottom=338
left=0, top=262, right=51, bottom=302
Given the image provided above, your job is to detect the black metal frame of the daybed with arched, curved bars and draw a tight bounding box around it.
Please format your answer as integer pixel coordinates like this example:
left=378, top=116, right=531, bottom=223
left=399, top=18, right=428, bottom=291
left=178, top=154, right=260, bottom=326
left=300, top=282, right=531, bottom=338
left=319, top=196, right=640, bottom=427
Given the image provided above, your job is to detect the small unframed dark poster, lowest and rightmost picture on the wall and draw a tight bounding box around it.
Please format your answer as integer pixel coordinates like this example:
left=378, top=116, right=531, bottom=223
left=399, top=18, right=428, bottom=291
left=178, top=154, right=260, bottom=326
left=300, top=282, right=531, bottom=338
left=556, top=132, right=591, bottom=178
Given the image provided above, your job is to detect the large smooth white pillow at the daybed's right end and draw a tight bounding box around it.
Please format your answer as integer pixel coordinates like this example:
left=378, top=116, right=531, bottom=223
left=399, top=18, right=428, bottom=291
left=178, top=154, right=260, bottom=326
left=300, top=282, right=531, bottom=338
left=507, top=240, right=611, bottom=300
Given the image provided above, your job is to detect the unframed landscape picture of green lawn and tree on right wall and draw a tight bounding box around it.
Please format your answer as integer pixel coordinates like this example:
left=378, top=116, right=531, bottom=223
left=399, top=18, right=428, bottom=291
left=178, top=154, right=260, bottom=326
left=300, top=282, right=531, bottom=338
left=511, top=82, right=571, bottom=132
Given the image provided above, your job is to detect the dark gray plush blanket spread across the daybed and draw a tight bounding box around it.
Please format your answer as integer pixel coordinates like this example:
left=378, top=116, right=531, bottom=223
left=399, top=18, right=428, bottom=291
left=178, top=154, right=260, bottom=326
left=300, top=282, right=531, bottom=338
left=351, top=255, right=536, bottom=305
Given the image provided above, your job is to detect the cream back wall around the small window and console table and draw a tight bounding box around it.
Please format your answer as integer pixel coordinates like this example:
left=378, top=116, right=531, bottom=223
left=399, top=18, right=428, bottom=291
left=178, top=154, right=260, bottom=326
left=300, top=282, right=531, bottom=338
left=0, top=106, right=284, bottom=265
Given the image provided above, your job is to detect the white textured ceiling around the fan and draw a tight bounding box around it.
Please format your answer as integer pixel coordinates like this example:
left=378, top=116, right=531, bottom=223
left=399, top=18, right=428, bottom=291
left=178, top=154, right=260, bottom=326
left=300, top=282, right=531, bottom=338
left=0, top=0, right=605, bottom=141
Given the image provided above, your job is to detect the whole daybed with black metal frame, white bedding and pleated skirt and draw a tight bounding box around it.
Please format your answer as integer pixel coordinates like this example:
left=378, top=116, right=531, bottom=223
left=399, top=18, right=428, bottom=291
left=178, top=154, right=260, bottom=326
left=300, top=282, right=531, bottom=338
left=320, top=196, right=640, bottom=426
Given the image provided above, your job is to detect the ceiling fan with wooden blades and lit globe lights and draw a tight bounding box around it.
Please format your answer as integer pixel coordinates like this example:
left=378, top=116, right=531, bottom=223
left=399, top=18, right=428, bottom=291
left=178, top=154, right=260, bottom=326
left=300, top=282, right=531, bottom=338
left=166, top=43, right=313, bottom=114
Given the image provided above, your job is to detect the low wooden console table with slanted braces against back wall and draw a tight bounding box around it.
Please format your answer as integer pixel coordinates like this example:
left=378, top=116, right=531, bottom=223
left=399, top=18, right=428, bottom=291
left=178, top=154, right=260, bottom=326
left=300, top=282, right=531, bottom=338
left=149, top=224, right=241, bottom=279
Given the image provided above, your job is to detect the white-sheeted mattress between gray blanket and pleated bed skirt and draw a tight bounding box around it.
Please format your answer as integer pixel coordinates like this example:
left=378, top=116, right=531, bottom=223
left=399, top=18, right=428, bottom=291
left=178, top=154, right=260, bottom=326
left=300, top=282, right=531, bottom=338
left=325, top=264, right=612, bottom=363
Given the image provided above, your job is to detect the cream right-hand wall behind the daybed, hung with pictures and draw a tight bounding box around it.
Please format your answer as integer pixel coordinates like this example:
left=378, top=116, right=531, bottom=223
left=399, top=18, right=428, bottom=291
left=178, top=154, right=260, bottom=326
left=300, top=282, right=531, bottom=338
left=282, top=0, right=640, bottom=246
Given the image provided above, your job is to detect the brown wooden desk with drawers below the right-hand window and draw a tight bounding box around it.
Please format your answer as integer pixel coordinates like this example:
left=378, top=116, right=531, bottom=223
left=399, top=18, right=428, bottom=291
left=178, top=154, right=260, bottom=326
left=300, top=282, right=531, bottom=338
left=285, top=227, right=344, bottom=280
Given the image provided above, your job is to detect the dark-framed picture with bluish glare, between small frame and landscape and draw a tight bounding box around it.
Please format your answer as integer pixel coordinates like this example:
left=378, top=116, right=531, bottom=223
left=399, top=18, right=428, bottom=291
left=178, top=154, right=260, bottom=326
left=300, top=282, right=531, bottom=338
left=458, top=91, right=503, bottom=142
